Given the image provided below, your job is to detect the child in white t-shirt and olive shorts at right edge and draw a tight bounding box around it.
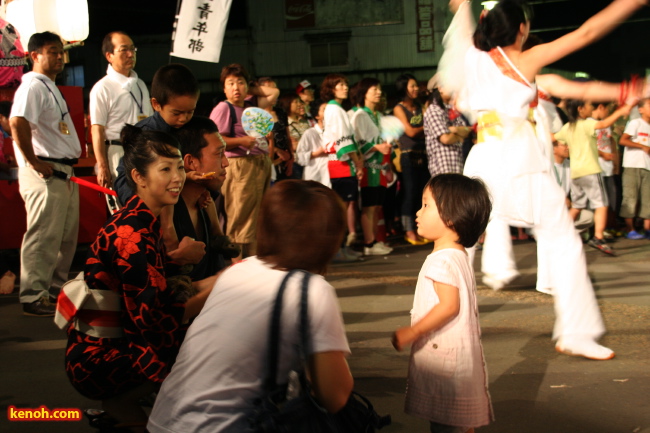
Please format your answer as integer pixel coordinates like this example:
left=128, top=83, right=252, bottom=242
left=619, top=98, right=650, bottom=239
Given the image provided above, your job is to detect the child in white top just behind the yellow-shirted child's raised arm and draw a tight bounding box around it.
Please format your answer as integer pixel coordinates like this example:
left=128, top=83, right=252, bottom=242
left=591, top=102, right=620, bottom=233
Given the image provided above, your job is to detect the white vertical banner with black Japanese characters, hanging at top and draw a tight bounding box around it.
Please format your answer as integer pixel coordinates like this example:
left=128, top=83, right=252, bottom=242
left=171, top=0, right=232, bottom=63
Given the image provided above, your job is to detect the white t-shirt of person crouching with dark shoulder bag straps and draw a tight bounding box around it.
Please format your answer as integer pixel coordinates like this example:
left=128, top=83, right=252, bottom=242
left=147, top=257, right=350, bottom=433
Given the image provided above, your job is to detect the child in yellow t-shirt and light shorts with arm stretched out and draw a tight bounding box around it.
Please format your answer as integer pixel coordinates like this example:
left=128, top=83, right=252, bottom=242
left=554, top=99, right=631, bottom=255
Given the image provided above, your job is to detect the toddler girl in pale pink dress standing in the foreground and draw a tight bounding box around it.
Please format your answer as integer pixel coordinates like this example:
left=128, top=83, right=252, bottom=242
left=393, top=173, right=494, bottom=433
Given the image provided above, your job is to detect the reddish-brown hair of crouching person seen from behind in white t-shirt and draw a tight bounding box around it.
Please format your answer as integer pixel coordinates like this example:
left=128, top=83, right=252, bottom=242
left=257, top=179, right=346, bottom=274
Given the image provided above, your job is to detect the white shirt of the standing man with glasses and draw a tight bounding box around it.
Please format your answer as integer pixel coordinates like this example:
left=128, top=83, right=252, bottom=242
left=90, top=64, right=153, bottom=140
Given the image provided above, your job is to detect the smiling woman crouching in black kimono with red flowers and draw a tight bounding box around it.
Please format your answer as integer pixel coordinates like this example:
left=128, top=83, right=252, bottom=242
left=65, top=125, right=215, bottom=431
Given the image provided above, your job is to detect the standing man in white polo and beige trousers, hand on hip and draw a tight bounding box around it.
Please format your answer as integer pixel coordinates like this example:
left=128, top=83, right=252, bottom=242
left=9, top=32, right=81, bottom=316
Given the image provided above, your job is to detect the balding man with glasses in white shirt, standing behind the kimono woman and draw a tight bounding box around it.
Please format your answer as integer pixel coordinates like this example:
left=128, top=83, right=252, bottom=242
left=90, top=32, right=153, bottom=212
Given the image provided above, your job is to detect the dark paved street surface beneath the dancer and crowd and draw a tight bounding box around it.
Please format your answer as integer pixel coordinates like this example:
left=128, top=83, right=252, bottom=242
left=0, top=240, right=650, bottom=433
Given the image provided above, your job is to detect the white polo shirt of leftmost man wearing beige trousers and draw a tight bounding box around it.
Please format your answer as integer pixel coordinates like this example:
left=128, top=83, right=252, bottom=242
left=9, top=72, right=81, bottom=167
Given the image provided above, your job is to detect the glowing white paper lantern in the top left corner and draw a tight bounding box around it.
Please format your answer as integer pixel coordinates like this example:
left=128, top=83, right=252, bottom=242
left=7, top=0, right=89, bottom=46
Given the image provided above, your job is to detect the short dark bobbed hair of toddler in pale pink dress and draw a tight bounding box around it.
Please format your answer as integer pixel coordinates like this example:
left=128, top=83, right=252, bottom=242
left=425, top=173, right=492, bottom=248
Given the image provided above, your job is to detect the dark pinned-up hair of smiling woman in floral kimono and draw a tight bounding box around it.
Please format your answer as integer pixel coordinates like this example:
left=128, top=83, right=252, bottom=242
left=120, top=125, right=181, bottom=191
